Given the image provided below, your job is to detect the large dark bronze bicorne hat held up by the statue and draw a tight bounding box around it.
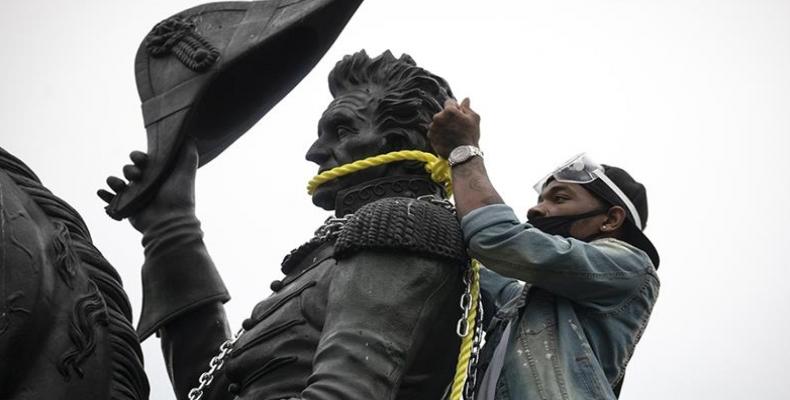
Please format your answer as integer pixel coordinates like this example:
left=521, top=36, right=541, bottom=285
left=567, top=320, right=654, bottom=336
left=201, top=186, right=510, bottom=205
left=106, top=0, right=362, bottom=219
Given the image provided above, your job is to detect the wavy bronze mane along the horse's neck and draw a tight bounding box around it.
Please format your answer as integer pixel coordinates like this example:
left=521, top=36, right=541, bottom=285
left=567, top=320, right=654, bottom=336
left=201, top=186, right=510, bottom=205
left=0, top=148, right=149, bottom=400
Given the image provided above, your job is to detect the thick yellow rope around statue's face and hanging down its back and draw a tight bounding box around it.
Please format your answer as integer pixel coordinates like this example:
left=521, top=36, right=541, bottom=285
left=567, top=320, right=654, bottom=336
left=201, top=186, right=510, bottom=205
left=307, top=150, right=480, bottom=400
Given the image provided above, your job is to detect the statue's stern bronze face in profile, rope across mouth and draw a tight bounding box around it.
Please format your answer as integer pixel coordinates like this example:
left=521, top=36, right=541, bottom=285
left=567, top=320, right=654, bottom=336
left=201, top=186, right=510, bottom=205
left=306, top=89, right=386, bottom=210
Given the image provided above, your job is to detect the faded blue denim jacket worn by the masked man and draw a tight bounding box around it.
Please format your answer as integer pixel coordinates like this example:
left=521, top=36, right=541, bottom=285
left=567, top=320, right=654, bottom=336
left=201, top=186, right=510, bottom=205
left=461, top=204, right=659, bottom=400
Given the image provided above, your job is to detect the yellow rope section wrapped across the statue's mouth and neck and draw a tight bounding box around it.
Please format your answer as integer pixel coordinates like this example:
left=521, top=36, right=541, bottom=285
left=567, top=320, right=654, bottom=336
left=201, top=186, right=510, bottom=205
left=307, top=150, right=453, bottom=196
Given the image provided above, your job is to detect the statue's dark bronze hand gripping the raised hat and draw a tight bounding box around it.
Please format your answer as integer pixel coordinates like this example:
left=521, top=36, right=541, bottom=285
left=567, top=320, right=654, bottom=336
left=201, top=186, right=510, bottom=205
left=97, top=140, right=198, bottom=233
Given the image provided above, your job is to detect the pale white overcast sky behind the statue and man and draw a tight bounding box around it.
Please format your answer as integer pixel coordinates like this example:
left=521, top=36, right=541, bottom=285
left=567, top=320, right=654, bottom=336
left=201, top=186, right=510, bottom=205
left=0, top=0, right=790, bottom=400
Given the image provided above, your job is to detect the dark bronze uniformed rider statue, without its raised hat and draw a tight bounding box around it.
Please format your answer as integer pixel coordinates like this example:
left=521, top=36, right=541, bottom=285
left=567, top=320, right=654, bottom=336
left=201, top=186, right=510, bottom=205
left=100, top=51, right=468, bottom=400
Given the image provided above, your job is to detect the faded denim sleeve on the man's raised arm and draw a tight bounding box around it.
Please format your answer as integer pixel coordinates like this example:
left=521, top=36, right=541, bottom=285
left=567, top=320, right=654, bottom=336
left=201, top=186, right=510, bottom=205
left=461, top=204, right=655, bottom=308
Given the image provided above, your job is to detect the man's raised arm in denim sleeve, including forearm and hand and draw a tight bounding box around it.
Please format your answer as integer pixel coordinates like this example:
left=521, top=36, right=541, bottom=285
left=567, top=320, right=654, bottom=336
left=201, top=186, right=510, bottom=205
left=428, top=99, right=652, bottom=304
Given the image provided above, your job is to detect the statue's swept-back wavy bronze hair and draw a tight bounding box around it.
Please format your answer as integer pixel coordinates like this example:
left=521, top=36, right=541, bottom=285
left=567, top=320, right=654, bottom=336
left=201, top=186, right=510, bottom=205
left=329, top=50, right=453, bottom=152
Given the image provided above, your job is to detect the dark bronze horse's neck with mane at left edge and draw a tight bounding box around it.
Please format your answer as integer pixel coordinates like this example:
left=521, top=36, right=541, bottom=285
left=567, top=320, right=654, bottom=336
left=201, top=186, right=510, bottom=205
left=0, top=148, right=148, bottom=400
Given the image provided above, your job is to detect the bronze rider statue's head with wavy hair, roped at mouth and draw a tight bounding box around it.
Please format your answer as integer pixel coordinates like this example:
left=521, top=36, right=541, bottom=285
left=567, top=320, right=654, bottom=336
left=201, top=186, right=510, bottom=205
left=306, top=50, right=453, bottom=210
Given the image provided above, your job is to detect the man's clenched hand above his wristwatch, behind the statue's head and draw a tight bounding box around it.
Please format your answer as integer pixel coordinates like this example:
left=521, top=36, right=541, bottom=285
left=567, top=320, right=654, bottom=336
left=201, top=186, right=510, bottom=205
left=428, top=97, right=480, bottom=159
